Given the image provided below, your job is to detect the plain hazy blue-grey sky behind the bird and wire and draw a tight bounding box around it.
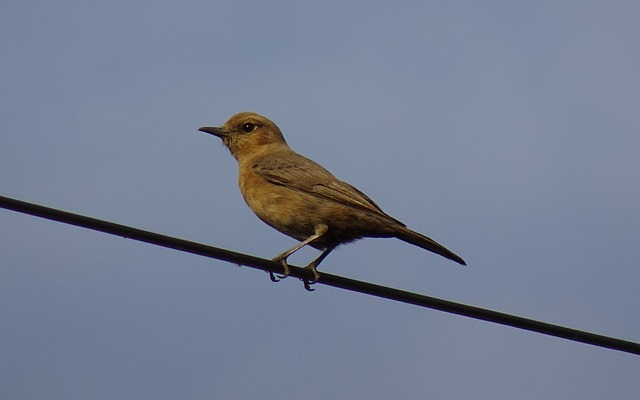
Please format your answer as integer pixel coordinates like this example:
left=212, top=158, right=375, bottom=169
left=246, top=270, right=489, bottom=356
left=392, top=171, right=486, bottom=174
left=0, top=0, right=640, bottom=400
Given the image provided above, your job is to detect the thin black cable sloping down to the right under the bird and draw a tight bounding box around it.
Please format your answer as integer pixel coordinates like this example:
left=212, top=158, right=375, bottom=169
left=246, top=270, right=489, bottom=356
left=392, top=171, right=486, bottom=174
left=0, top=196, right=640, bottom=354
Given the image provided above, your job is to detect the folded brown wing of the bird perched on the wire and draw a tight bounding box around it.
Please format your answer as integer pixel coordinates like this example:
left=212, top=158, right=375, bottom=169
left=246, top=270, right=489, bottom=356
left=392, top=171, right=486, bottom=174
left=252, top=152, right=404, bottom=226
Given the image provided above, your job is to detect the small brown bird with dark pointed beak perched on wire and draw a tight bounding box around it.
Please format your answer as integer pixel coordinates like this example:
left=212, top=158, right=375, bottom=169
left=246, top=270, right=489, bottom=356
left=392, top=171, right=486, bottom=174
left=199, top=112, right=466, bottom=289
